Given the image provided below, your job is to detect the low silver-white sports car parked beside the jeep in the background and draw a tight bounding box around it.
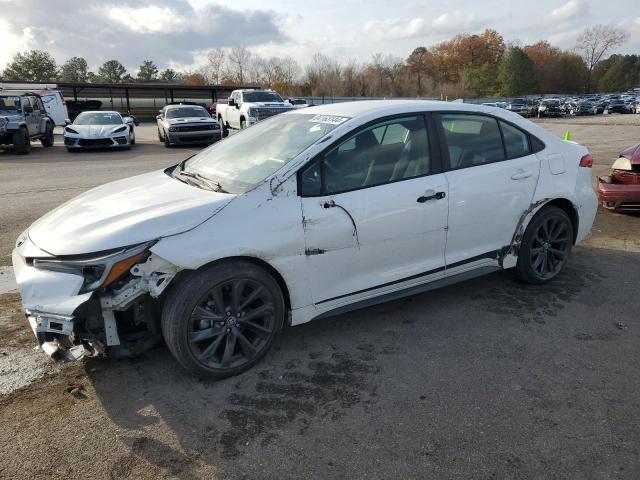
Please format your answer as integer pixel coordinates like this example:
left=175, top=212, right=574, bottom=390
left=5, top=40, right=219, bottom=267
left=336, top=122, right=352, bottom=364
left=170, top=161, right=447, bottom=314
left=63, top=111, right=136, bottom=151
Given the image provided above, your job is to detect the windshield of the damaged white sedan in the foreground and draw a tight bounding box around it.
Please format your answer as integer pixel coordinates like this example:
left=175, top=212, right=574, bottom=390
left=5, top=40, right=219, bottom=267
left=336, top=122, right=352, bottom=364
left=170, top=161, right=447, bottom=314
left=184, top=113, right=348, bottom=193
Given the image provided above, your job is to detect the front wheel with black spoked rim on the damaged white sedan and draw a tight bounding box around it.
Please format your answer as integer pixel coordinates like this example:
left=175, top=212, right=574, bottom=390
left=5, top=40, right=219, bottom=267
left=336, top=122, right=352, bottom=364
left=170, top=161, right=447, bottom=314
left=162, top=261, right=286, bottom=378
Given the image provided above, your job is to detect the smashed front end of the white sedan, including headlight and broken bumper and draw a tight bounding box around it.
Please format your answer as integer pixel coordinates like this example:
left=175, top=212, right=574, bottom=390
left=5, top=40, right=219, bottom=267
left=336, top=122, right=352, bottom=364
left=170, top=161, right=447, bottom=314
left=12, top=235, right=179, bottom=361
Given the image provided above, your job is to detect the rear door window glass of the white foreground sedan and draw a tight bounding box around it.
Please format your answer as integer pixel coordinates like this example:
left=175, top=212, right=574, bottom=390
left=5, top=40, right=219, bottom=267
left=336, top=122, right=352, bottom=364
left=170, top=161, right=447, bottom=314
left=438, top=114, right=505, bottom=169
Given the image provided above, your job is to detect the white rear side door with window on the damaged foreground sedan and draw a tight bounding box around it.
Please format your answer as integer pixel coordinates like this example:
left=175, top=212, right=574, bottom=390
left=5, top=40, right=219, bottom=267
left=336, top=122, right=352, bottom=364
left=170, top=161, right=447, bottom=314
left=435, top=113, right=540, bottom=269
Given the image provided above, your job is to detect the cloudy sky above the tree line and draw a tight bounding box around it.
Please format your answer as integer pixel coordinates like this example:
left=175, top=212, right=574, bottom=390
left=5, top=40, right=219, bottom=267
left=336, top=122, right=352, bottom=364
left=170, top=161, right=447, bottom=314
left=0, top=0, right=640, bottom=72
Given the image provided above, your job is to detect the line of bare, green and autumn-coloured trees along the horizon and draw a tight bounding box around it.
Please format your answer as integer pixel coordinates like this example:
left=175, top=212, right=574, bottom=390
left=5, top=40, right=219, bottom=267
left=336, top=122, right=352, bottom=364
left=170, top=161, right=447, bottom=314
left=2, top=25, right=640, bottom=98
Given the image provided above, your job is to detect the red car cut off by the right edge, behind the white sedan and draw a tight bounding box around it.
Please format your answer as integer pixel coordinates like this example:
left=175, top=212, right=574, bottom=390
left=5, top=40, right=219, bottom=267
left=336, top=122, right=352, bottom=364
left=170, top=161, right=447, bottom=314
left=598, top=144, right=640, bottom=212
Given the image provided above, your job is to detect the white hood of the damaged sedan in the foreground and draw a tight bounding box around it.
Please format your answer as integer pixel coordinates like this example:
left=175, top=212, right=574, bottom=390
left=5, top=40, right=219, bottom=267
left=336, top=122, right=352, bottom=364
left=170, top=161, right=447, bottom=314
left=29, top=171, right=235, bottom=256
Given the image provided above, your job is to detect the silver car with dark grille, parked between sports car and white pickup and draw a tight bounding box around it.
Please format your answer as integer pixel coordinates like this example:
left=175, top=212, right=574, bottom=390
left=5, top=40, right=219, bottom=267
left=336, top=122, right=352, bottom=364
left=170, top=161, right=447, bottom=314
left=156, top=104, right=222, bottom=147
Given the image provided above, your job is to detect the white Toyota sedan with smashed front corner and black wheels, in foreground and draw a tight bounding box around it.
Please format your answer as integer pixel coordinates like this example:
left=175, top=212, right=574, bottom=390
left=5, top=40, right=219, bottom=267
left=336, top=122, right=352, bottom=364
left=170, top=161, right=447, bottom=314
left=13, top=101, right=597, bottom=377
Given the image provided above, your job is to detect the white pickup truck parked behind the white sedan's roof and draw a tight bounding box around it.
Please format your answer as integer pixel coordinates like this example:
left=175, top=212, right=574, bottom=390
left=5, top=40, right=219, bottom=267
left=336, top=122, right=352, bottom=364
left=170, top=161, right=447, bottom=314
left=216, top=89, right=294, bottom=136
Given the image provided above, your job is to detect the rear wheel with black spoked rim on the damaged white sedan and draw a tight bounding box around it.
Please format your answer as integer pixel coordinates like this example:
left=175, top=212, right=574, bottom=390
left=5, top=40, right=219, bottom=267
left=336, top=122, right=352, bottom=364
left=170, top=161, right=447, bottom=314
left=515, top=206, right=573, bottom=285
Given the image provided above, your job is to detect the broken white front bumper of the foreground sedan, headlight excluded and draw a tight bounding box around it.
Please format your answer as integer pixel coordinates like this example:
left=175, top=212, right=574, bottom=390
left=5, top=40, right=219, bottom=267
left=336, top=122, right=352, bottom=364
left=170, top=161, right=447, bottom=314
left=12, top=236, right=178, bottom=361
